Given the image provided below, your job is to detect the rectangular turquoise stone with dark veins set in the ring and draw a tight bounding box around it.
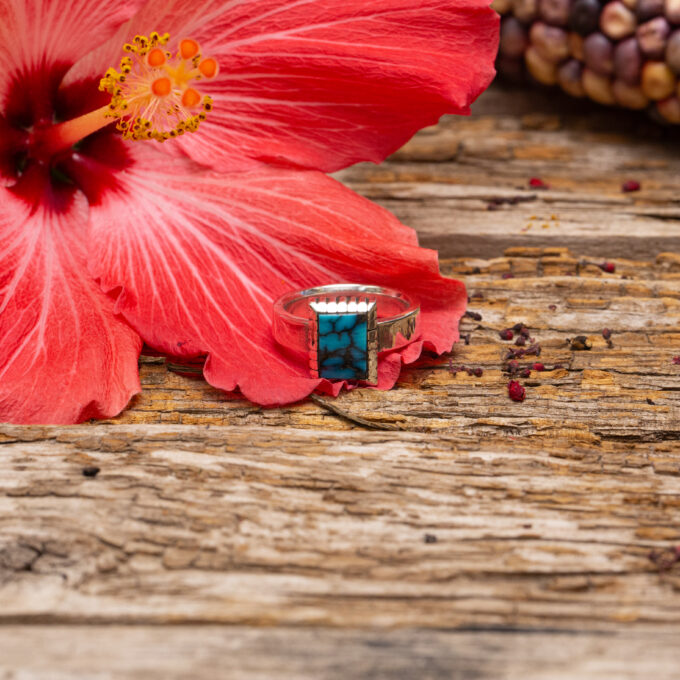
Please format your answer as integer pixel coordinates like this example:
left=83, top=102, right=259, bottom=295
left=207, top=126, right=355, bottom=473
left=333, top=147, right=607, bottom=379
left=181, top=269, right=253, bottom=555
left=317, top=313, right=368, bottom=380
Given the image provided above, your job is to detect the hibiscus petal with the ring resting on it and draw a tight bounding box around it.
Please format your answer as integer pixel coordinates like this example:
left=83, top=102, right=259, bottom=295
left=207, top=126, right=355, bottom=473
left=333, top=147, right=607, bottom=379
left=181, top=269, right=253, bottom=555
left=80, top=145, right=466, bottom=404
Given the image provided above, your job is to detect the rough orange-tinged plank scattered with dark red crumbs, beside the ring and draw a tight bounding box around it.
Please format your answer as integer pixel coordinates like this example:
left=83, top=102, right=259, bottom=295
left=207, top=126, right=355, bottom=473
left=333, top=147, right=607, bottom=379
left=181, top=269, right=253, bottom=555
left=102, top=249, right=680, bottom=445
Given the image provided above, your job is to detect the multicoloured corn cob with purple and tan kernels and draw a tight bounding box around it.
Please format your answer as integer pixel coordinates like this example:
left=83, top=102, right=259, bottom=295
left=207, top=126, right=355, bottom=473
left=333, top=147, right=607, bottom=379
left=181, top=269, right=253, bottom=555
left=492, top=0, right=680, bottom=124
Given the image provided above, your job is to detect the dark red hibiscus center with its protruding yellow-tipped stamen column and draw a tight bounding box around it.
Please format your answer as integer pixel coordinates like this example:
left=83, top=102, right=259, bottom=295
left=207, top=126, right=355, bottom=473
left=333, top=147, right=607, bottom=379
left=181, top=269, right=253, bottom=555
left=0, top=32, right=218, bottom=202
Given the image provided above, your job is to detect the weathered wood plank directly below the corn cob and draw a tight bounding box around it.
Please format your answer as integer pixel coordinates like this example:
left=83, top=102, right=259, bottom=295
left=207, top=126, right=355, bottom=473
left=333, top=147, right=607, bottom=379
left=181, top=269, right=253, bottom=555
left=338, top=86, right=680, bottom=258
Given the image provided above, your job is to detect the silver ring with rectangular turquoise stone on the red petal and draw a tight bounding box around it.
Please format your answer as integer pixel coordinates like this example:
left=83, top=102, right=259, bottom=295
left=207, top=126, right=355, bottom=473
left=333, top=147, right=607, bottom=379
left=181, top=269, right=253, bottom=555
left=273, top=283, right=420, bottom=385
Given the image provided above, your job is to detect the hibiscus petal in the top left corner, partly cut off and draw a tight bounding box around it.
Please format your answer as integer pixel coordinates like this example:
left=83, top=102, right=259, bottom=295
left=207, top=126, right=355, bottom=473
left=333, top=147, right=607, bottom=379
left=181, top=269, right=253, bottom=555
left=0, top=0, right=145, bottom=126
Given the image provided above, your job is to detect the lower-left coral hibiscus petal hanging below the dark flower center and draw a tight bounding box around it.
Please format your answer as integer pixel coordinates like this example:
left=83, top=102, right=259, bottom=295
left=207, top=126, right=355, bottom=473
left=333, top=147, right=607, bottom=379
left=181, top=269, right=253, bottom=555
left=0, top=170, right=141, bottom=423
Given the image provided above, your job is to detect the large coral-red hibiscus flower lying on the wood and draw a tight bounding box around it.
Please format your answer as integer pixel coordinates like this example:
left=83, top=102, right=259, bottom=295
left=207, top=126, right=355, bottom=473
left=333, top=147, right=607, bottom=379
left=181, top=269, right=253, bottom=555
left=0, top=0, right=498, bottom=423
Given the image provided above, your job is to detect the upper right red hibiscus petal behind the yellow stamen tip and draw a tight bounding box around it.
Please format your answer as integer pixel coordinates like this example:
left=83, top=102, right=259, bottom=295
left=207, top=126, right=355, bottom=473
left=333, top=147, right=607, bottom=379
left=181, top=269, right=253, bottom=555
left=65, top=0, right=498, bottom=172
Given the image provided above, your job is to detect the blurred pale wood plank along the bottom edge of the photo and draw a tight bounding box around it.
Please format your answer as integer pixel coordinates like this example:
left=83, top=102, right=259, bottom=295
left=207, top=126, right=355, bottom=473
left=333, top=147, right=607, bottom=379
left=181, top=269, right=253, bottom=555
left=0, top=626, right=680, bottom=680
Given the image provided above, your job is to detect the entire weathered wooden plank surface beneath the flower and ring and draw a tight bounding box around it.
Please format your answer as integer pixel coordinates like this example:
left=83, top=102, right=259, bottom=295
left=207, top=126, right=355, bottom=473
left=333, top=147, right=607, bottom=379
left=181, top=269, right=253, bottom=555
left=0, top=83, right=680, bottom=680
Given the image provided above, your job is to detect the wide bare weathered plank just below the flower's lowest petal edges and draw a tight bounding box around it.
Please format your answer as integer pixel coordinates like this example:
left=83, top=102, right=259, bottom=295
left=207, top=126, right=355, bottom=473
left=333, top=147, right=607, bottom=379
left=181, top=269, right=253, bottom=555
left=0, top=425, right=680, bottom=631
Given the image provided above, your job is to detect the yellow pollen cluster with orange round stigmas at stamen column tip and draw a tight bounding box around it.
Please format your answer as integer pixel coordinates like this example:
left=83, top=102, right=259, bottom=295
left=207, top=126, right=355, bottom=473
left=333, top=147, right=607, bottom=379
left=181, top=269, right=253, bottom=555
left=99, top=31, right=219, bottom=142
